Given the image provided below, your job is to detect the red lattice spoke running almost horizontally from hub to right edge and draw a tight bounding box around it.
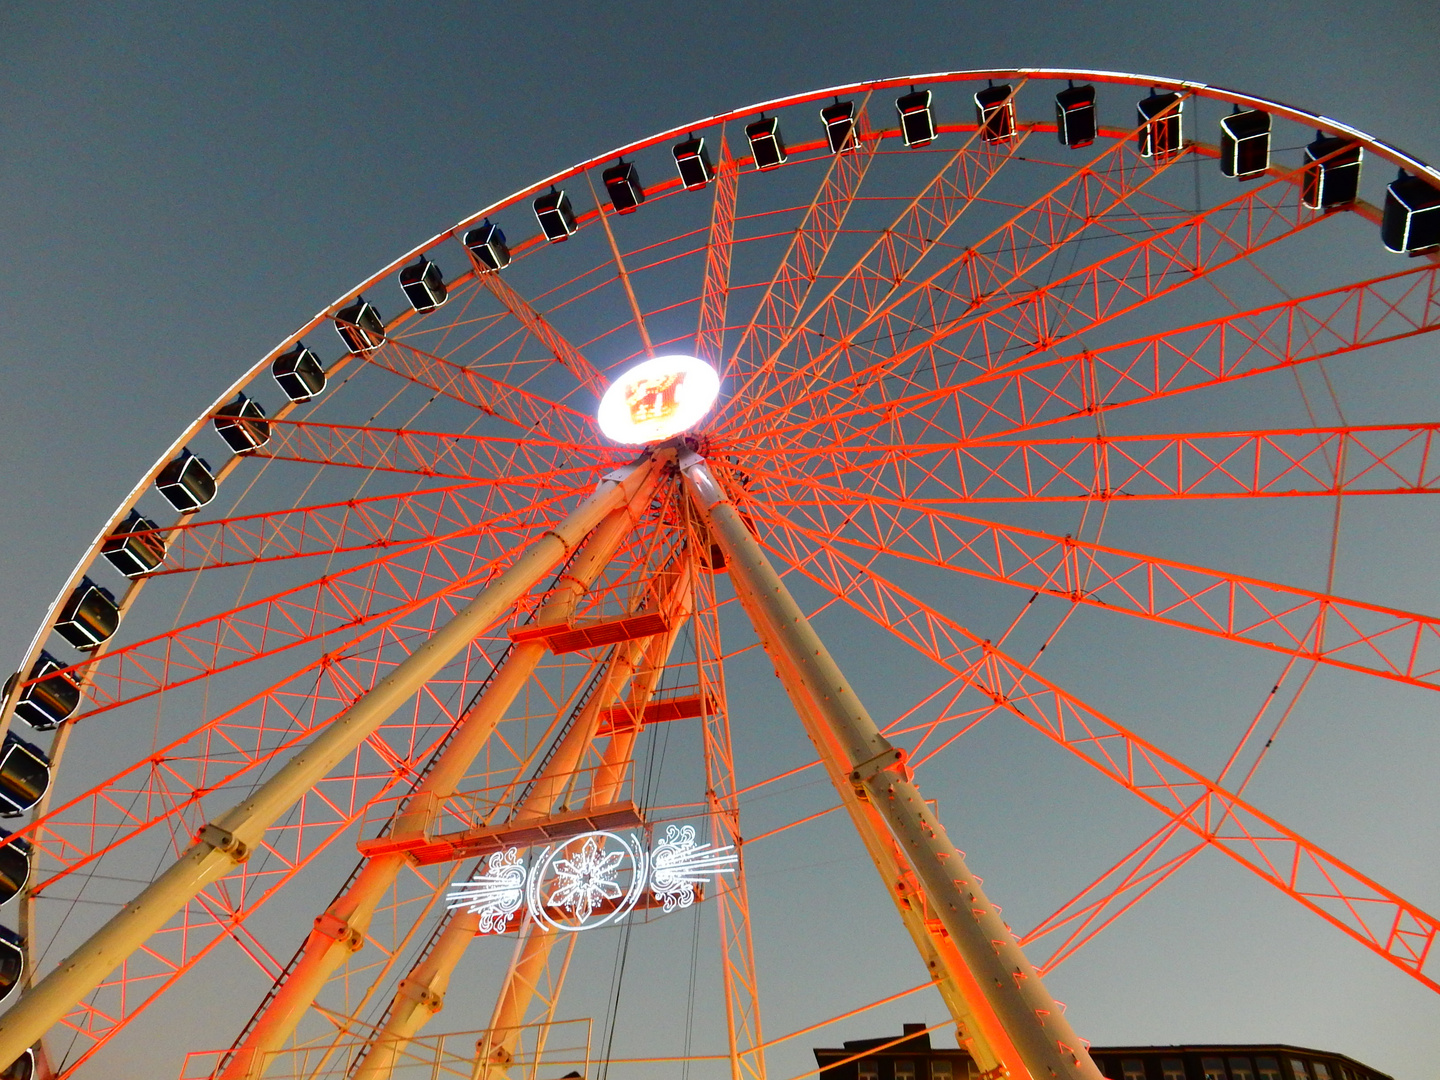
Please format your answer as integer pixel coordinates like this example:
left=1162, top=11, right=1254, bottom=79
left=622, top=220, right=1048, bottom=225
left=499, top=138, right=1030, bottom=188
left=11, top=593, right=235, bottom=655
left=766, top=423, right=1440, bottom=513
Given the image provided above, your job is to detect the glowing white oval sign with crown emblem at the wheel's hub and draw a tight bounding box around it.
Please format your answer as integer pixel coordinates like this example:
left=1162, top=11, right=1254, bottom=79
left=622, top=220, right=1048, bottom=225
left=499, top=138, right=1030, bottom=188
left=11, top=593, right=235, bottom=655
left=596, top=356, right=720, bottom=445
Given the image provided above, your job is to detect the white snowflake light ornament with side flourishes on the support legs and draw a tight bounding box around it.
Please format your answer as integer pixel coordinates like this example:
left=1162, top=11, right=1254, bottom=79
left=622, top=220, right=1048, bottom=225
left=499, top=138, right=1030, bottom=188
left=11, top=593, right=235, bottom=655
left=446, top=825, right=740, bottom=933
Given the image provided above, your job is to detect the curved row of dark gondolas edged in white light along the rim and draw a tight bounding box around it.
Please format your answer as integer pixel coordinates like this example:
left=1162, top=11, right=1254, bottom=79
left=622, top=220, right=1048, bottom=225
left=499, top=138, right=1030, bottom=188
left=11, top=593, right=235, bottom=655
left=0, top=82, right=1440, bottom=1025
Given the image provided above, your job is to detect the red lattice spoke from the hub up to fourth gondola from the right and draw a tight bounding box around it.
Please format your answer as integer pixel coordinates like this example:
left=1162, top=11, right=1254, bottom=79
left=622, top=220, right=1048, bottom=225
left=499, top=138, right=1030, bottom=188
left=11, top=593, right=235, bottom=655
left=726, top=121, right=1192, bottom=426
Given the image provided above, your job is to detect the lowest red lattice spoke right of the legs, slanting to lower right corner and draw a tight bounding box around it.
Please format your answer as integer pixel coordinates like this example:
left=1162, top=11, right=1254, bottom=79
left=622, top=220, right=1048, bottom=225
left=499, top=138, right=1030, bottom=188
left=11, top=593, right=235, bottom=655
left=762, top=531, right=1440, bottom=991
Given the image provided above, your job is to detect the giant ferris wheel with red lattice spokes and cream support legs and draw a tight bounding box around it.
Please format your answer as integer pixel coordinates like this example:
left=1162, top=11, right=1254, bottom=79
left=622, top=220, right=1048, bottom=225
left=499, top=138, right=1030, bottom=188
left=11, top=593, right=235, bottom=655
left=0, top=69, right=1440, bottom=1080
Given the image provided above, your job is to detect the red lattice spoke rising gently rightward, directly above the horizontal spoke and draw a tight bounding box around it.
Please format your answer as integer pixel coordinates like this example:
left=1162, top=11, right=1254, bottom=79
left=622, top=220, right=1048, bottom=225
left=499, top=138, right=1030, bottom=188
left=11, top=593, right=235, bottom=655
left=794, top=265, right=1440, bottom=442
